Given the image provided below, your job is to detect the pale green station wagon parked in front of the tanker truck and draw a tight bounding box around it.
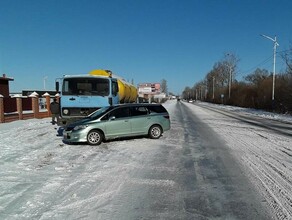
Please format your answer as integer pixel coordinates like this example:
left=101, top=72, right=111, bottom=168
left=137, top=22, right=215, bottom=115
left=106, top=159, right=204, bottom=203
left=63, top=103, right=170, bottom=145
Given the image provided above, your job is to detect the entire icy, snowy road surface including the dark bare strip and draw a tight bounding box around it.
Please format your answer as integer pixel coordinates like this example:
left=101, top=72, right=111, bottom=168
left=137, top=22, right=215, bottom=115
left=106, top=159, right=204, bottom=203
left=0, top=101, right=292, bottom=220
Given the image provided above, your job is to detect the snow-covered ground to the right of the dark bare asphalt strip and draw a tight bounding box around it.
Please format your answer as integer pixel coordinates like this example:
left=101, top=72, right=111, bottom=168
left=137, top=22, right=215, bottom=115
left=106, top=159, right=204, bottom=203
left=187, top=102, right=292, bottom=219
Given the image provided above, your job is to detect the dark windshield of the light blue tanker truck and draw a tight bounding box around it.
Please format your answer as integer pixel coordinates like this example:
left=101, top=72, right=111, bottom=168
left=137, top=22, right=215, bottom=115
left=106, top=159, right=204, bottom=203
left=62, top=78, right=109, bottom=96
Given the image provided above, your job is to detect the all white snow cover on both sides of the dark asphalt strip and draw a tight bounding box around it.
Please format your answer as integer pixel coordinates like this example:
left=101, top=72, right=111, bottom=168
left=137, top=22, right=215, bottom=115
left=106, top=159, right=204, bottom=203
left=0, top=101, right=292, bottom=219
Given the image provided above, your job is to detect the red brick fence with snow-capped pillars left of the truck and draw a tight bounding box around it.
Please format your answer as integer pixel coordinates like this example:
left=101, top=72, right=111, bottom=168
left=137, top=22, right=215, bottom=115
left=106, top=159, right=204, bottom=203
left=0, top=93, right=59, bottom=123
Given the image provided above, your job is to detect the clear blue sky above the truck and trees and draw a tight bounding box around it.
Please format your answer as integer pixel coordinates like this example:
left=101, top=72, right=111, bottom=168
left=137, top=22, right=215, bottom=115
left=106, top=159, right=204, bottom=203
left=0, top=0, right=292, bottom=94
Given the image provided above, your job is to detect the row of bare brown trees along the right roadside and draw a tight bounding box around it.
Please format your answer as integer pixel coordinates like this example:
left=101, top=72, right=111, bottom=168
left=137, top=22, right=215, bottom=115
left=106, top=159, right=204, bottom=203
left=182, top=46, right=292, bottom=114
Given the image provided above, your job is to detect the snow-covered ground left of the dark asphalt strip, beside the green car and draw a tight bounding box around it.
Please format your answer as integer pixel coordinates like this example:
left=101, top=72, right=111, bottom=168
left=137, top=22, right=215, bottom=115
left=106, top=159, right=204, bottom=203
left=0, top=119, right=171, bottom=219
